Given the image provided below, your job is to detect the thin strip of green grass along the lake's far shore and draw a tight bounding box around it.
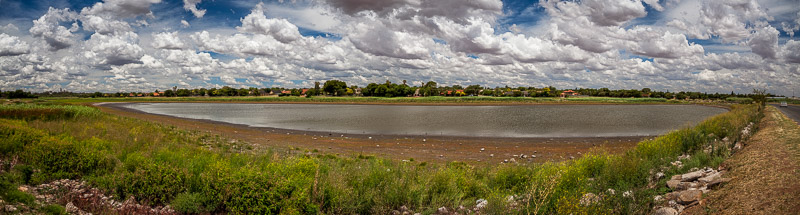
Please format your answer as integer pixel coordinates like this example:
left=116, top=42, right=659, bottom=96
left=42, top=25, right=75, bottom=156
left=47, top=96, right=680, bottom=104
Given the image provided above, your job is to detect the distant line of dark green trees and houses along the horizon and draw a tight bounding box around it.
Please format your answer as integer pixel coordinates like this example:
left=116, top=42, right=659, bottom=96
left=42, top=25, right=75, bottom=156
left=0, top=80, right=774, bottom=100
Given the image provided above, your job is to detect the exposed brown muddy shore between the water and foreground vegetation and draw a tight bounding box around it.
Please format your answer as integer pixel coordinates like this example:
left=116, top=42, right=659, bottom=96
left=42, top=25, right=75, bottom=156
left=99, top=103, right=652, bottom=164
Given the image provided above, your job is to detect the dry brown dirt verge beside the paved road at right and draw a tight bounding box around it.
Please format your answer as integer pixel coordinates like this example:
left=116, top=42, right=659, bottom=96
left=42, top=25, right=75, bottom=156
left=686, top=106, right=800, bottom=214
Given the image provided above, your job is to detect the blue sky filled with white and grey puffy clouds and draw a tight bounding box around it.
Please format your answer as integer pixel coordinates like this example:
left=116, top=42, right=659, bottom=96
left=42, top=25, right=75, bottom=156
left=0, top=0, right=800, bottom=96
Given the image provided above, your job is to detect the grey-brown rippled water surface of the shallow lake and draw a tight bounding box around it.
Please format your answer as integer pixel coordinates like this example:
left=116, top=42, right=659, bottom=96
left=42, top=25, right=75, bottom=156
left=122, top=103, right=727, bottom=137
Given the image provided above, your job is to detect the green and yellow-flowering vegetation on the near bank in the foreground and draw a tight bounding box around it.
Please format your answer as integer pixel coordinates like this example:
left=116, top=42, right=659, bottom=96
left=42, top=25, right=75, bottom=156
left=0, top=102, right=760, bottom=214
